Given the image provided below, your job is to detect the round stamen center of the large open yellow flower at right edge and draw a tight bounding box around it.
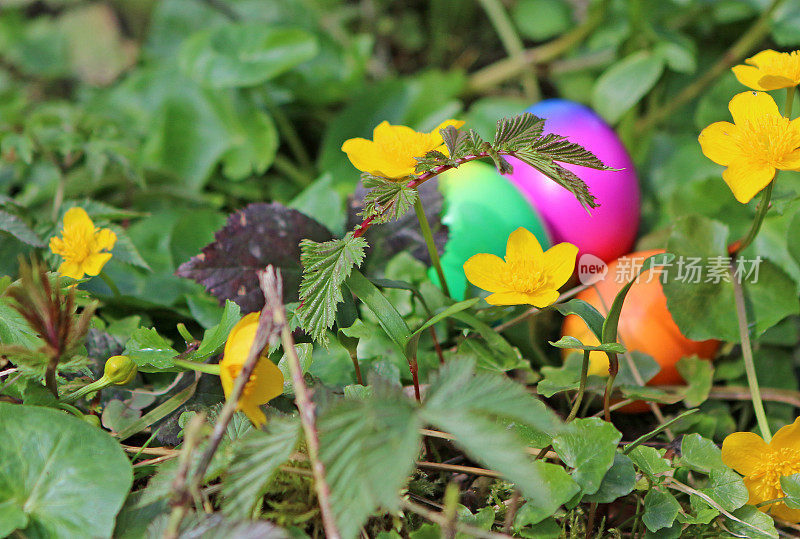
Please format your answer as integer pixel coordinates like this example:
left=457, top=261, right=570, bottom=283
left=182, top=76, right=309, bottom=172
left=736, top=116, right=800, bottom=168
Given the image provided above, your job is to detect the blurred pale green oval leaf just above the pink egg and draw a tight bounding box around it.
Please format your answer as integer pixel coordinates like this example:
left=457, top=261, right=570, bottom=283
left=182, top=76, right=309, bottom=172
left=592, top=51, right=664, bottom=124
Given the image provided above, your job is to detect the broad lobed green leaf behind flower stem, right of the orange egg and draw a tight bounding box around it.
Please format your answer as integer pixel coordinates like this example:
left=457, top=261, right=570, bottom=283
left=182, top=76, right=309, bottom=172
left=664, top=216, right=800, bottom=342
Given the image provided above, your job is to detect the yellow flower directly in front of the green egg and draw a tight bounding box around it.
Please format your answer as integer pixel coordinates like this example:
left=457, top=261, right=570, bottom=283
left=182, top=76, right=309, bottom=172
left=464, top=227, right=578, bottom=307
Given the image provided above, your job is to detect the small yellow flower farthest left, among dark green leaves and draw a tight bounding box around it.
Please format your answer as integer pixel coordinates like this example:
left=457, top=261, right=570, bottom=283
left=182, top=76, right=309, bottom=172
left=50, top=207, right=117, bottom=279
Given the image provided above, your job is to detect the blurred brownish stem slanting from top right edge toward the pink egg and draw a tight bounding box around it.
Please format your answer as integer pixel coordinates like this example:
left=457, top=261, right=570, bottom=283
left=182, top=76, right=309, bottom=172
left=636, top=0, right=784, bottom=133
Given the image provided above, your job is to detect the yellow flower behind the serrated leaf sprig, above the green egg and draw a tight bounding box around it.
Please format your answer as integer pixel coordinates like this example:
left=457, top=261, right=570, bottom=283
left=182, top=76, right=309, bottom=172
left=342, top=120, right=464, bottom=179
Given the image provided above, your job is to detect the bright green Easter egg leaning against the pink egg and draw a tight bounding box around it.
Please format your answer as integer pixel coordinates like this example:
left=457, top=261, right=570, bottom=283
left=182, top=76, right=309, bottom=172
left=428, top=161, right=550, bottom=299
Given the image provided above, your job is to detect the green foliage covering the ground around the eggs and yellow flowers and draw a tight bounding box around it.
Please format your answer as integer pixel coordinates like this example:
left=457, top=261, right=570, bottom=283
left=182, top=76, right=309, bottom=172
left=0, top=0, right=800, bottom=539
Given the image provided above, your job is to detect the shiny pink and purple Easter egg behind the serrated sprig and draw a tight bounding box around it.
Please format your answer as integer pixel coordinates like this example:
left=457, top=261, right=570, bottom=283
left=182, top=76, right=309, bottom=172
left=509, top=99, right=639, bottom=262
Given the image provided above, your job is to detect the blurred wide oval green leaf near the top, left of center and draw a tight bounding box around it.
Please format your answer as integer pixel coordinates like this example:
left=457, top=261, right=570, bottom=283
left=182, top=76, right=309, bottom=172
left=179, top=22, right=317, bottom=88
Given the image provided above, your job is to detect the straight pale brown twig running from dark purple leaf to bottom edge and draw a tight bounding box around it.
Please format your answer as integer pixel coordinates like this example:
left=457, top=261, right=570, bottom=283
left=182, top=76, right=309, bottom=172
left=258, top=265, right=341, bottom=539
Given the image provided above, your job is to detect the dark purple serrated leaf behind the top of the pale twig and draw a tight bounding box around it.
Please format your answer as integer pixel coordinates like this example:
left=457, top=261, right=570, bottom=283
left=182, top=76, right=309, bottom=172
left=175, top=202, right=331, bottom=312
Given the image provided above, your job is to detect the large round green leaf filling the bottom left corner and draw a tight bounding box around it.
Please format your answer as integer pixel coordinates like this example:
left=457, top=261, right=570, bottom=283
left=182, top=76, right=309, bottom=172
left=0, top=402, right=133, bottom=539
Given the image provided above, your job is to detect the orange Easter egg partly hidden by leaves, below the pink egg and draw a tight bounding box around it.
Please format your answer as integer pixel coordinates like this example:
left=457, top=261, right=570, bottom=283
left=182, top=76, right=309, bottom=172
left=561, top=250, right=719, bottom=411
